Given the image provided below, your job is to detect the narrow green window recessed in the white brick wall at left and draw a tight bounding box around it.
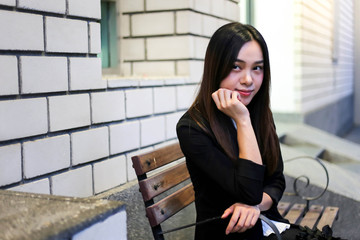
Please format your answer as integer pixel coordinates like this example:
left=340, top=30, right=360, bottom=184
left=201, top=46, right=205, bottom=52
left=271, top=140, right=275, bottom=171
left=100, top=1, right=119, bottom=73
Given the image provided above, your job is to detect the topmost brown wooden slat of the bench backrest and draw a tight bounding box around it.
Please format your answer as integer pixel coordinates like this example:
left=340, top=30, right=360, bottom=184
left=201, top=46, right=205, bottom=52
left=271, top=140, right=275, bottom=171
left=131, top=143, right=184, bottom=176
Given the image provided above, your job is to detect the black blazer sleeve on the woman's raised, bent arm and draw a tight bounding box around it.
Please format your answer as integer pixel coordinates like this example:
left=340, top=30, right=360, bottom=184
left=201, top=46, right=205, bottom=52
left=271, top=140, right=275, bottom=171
left=177, top=117, right=265, bottom=205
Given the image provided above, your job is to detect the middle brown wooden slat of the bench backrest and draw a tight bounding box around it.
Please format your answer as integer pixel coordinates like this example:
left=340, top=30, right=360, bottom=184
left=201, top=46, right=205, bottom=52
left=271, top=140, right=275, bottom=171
left=139, top=162, right=190, bottom=201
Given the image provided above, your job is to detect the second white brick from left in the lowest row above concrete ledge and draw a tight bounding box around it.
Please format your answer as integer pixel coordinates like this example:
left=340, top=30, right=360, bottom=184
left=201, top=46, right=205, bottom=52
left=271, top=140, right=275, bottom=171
left=51, top=166, right=93, bottom=197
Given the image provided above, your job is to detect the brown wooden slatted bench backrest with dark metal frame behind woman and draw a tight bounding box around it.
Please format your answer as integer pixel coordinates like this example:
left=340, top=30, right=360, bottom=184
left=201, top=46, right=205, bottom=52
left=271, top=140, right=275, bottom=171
left=131, top=143, right=194, bottom=240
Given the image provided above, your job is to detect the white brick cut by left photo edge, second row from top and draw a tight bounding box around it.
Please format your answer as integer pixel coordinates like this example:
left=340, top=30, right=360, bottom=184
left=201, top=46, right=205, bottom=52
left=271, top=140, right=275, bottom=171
left=0, top=10, right=44, bottom=51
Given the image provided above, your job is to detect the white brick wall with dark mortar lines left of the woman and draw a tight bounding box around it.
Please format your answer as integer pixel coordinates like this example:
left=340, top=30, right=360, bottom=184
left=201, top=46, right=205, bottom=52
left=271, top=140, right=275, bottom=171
left=0, top=0, right=239, bottom=197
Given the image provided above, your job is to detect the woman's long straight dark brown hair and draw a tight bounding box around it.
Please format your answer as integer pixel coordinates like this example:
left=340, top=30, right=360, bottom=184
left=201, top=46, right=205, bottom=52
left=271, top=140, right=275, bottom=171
left=189, top=23, right=280, bottom=174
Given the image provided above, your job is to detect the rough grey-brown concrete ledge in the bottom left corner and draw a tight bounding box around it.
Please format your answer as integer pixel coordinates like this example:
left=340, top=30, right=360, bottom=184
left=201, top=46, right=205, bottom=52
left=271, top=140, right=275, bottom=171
left=0, top=190, right=126, bottom=240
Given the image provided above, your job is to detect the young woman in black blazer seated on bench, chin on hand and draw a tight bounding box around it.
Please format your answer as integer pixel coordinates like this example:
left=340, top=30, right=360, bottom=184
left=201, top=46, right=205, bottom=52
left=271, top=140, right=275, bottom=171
left=177, top=23, right=287, bottom=240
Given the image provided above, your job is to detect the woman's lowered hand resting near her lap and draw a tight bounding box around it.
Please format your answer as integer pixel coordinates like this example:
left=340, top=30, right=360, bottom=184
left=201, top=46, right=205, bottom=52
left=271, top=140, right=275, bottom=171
left=221, top=203, right=260, bottom=235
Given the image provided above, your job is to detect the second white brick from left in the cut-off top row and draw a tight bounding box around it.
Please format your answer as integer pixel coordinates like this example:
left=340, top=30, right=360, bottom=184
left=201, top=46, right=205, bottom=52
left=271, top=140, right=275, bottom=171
left=18, top=0, right=66, bottom=14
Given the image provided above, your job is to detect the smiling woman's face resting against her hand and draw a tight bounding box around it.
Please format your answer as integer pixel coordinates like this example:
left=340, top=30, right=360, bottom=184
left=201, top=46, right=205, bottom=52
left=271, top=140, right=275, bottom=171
left=220, top=41, right=264, bottom=106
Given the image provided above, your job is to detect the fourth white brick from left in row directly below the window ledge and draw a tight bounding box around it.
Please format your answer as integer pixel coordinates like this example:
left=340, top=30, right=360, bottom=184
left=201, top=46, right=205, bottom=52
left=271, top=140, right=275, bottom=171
left=125, top=88, right=153, bottom=118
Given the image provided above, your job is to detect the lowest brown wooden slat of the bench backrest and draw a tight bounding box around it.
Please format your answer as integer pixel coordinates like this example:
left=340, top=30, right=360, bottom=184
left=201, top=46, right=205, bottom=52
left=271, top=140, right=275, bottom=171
left=146, top=183, right=195, bottom=227
